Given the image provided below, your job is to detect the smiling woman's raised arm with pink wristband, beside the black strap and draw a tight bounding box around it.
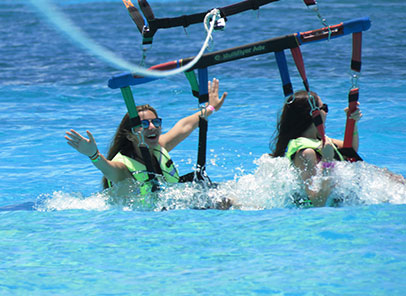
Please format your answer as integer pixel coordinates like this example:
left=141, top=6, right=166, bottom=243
left=159, top=78, right=227, bottom=151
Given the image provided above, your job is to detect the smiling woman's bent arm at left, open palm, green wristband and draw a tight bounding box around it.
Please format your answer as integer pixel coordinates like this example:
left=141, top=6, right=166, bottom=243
left=65, top=129, right=131, bottom=182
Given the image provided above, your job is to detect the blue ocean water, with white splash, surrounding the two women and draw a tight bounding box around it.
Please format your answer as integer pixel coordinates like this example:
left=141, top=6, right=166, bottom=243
left=0, top=0, right=406, bottom=295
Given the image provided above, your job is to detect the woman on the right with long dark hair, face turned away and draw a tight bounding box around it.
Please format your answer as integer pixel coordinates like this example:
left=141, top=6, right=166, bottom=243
left=271, top=91, right=362, bottom=206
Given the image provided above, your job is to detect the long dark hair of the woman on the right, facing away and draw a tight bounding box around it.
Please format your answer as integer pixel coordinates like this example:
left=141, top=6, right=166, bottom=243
left=271, top=90, right=320, bottom=157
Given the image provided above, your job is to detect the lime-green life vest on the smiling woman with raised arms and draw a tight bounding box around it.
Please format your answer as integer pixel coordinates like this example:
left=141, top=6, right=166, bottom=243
left=107, top=147, right=179, bottom=195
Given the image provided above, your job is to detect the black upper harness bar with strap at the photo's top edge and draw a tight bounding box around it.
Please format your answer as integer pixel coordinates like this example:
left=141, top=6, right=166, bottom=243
left=123, top=0, right=279, bottom=44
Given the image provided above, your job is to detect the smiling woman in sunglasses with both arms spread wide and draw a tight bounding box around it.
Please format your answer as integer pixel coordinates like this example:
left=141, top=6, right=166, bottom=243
left=65, top=78, right=227, bottom=199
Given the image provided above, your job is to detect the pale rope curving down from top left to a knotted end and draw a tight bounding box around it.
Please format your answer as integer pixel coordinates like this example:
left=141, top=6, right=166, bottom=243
left=29, top=0, right=220, bottom=77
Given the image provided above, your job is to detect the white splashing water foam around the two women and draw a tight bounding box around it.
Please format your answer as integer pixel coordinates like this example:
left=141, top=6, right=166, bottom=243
left=35, top=155, right=406, bottom=211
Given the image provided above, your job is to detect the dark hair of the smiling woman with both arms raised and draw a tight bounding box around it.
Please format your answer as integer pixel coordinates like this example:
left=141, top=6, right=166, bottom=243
left=102, top=104, right=158, bottom=189
